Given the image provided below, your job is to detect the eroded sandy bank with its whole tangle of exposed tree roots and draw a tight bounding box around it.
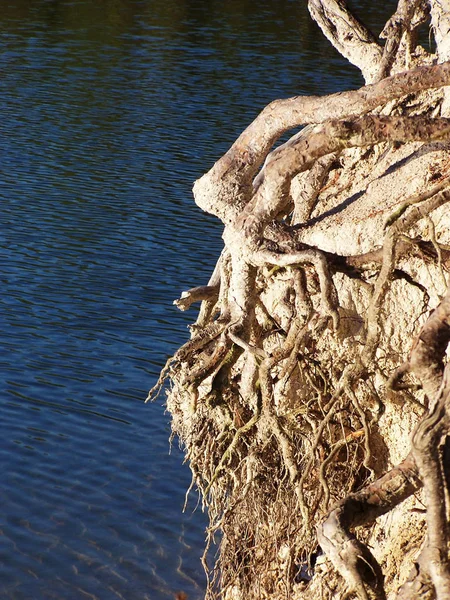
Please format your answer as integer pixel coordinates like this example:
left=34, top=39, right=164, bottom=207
left=149, top=0, right=450, bottom=600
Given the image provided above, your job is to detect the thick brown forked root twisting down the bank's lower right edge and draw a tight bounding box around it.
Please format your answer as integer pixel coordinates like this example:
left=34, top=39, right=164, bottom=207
left=318, top=288, right=450, bottom=600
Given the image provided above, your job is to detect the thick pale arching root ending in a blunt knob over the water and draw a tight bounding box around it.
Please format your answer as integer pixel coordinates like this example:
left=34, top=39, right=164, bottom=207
left=193, top=63, right=450, bottom=225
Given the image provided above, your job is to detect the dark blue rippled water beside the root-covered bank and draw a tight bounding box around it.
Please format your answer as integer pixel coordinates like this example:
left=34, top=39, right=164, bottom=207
left=0, top=0, right=394, bottom=600
